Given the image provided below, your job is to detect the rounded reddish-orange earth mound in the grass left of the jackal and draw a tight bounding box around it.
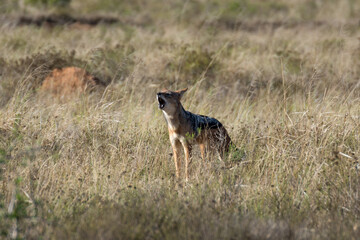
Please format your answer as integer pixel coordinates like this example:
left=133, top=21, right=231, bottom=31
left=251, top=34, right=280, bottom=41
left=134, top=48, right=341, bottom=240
left=41, top=67, right=96, bottom=97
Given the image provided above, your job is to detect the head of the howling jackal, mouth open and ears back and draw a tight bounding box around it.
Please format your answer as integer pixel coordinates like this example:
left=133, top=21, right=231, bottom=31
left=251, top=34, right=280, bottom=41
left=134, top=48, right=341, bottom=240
left=156, top=88, right=187, bottom=114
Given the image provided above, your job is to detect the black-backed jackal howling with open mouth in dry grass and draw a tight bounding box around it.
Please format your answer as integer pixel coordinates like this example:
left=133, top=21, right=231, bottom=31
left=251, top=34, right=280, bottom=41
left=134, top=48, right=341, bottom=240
left=157, top=88, right=231, bottom=180
